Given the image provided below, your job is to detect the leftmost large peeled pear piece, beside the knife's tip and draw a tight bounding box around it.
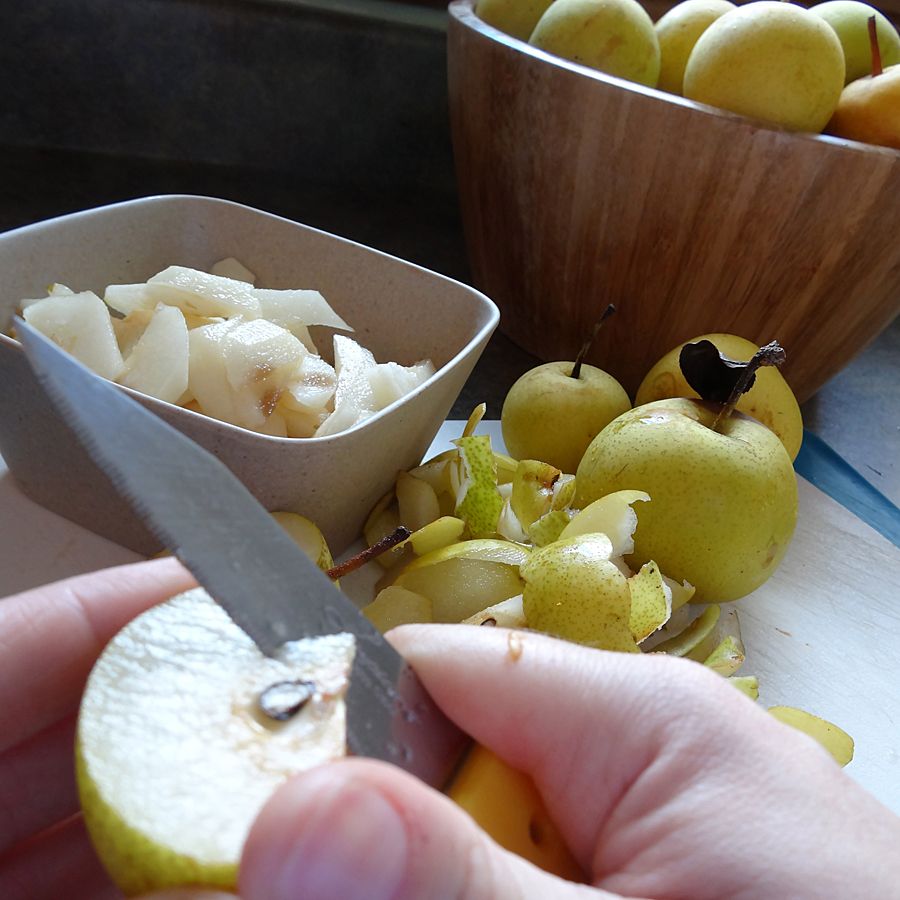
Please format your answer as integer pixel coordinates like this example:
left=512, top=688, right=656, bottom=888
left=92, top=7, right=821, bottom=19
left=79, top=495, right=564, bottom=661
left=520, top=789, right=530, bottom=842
left=22, top=291, right=125, bottom=380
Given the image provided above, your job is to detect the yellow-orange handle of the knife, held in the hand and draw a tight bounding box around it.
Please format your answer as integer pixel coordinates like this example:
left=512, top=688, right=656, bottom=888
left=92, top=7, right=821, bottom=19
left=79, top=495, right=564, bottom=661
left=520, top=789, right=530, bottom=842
left=447, top=744, right=585, bottom=884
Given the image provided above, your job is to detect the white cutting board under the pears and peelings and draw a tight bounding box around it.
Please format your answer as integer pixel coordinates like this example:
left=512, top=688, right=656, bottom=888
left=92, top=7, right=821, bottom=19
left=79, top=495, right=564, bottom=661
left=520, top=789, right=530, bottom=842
left=0, top=422, right=900, bottom=814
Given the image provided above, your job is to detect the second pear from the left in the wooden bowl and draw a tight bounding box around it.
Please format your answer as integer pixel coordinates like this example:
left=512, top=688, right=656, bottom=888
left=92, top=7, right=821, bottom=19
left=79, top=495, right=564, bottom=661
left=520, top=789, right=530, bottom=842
left=529, top=0, right=659, bottom=87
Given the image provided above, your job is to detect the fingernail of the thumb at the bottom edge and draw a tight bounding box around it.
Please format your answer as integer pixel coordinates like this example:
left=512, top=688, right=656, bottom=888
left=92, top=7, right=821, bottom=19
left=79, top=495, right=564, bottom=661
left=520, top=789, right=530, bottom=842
left=270, top=765, right=407, bottom=900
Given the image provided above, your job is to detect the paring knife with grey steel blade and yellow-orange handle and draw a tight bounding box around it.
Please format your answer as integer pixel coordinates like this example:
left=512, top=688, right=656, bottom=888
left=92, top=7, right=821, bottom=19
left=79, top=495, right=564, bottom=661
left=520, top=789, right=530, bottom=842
left=15, top=318, right=583, bottom=880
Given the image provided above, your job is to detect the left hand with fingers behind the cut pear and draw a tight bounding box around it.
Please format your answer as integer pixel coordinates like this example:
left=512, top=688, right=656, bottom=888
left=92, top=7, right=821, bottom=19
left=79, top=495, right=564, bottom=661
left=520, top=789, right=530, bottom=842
left=0, top=559, right=195, bottom=900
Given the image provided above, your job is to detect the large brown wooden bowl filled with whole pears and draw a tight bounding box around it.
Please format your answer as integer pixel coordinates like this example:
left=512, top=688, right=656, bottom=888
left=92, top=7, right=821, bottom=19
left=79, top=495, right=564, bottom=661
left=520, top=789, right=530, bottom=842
left=448, top=0, right=900, bottom=402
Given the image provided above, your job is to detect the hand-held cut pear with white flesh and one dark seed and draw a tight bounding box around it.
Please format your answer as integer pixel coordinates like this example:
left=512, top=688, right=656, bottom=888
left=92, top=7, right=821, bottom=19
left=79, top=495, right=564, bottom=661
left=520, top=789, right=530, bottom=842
left=76, top=589, right=355, bottom=894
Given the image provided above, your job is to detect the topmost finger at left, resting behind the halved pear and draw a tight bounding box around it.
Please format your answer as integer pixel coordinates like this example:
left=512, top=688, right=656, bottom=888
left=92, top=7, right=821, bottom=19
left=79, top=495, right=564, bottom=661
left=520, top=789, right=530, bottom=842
left=0, top=558, right=195, bottom=753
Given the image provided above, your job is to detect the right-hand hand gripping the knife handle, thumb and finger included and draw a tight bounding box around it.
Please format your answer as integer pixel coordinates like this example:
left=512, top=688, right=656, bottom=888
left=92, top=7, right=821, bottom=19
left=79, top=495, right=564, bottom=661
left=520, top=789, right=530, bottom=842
left=232, top=625, right=900, bottom=900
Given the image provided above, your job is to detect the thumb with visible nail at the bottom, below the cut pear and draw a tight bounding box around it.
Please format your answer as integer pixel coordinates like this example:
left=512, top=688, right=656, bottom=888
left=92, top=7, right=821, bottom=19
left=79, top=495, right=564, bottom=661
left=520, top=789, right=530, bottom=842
left=240, top=759, right=611, bottom=900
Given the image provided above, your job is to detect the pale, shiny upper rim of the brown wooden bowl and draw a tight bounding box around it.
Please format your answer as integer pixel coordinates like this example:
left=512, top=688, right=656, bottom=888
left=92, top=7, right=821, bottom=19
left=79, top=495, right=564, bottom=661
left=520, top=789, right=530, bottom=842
left=448, top=0, right=900, bottom=159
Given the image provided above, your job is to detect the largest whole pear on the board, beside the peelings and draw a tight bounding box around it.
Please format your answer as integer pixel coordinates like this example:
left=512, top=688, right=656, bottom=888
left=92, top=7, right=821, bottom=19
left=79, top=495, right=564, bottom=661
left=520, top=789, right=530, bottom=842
left=575, top=398, right=797, bottom=603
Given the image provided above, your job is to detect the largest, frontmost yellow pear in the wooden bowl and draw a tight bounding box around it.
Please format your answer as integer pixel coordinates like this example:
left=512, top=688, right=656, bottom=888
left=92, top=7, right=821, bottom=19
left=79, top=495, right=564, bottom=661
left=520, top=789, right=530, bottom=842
left=684, top=0, right=844, bottom=132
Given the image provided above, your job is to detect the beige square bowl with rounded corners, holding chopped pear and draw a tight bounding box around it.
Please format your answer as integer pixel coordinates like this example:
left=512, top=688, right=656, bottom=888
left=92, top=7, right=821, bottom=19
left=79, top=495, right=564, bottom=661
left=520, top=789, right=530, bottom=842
left=0, top=196, right=499, bottom=554
